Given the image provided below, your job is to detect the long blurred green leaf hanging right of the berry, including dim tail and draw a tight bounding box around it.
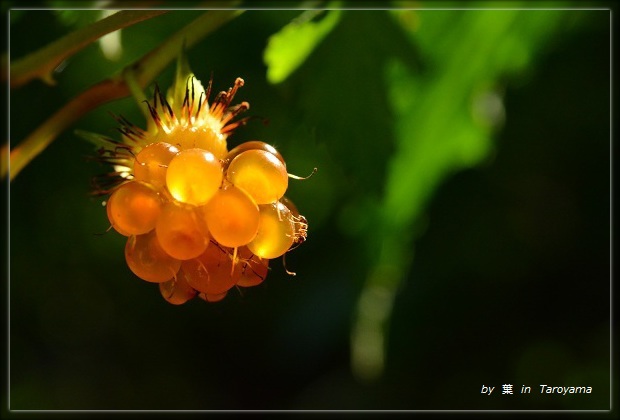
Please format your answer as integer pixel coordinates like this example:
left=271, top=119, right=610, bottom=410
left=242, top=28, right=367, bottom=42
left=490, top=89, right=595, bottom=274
left=352, top=10, right=563, bottom=380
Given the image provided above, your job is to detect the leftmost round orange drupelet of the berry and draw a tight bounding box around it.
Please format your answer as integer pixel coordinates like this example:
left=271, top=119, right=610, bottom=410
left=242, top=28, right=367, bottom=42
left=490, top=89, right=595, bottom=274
left=106, top=181, right=163, bottom=236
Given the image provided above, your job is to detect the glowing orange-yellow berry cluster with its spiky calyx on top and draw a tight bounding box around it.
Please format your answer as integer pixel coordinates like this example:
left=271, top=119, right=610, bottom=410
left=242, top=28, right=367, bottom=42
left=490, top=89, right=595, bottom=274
left=95, top=70, right=308, bottom=305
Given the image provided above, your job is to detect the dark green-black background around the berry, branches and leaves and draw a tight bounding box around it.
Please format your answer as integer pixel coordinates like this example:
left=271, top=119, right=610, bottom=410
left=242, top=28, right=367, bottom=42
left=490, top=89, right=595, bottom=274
left=3, top=0, right=615, bottom=410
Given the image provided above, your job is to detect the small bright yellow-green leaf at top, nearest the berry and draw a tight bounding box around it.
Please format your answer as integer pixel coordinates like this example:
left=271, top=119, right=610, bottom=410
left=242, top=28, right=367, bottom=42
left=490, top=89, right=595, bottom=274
left=263, top=10, right=341, bottom=84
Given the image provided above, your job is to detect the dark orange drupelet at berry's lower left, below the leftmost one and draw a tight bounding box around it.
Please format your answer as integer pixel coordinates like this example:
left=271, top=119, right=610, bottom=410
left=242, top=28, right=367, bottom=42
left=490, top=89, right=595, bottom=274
left=125, top=230, right=181, bottom=283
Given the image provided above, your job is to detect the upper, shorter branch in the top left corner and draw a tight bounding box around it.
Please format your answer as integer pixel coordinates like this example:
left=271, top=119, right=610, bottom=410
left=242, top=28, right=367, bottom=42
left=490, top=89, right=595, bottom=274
left=10, top=10, right=168, bottom=88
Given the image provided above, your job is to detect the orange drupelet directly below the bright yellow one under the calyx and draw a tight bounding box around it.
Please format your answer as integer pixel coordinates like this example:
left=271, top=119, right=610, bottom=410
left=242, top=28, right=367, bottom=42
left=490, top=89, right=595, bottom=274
left=155, top=201, right=209, bottom=260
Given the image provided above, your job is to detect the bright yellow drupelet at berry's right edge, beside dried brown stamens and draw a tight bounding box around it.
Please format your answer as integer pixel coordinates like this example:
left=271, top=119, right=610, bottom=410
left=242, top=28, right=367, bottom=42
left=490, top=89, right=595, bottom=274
left=247, top=201, right=295, bottom=259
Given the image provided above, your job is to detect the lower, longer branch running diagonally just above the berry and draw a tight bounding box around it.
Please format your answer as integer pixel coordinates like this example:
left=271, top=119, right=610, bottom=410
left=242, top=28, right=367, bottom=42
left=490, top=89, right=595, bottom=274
left=7, top=10, right=243, bottom=180
